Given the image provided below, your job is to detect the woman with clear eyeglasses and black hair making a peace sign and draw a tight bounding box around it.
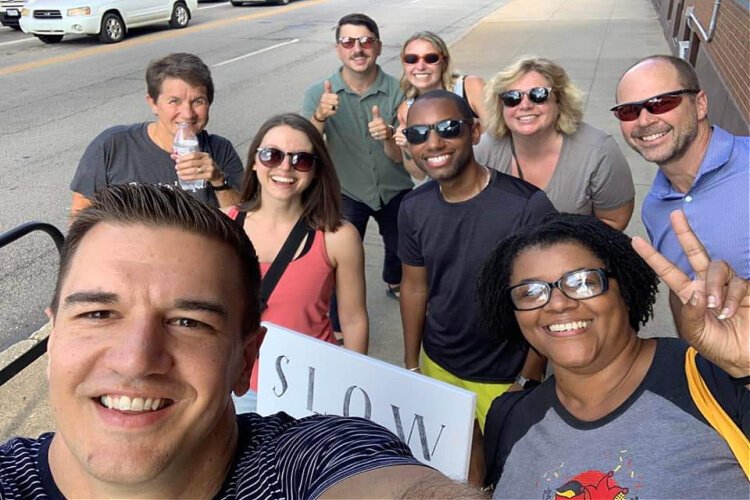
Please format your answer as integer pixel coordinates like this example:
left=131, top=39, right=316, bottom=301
left=477, top=212, right=750, bottom=499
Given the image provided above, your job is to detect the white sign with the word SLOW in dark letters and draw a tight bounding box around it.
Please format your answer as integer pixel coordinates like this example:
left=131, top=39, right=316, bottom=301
left=257, top=323, right=476, bottom=481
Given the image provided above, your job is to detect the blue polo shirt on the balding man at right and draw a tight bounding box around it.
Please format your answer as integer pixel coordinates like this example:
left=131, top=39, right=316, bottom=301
left=641, top=126, right=750, bottom=278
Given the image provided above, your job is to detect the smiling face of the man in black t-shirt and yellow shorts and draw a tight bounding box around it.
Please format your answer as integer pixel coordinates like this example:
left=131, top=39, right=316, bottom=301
left=407, top=99, right=481, bottom=182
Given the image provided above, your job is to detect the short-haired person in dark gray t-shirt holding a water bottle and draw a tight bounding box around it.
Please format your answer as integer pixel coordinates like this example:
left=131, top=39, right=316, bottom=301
left=70, top=53, right=243, bottom=214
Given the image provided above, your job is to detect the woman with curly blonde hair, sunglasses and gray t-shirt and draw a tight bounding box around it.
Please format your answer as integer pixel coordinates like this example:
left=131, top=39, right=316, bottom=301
left=474, top=57, right=635, bottom=230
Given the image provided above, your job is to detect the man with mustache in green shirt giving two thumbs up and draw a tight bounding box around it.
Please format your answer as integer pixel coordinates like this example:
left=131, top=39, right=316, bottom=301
left=302, top=14, right=413, bottom=304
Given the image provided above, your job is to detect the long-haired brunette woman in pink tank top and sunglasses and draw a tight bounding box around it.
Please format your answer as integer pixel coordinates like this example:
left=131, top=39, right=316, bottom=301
left=228, top=113, right=369, bottom=410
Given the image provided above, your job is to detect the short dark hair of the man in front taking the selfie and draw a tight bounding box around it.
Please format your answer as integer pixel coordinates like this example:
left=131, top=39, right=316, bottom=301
left=50, top=184, right=260, bottom=335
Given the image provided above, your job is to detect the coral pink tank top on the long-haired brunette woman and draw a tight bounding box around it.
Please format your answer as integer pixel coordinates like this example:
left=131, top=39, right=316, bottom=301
left=250, top=227, right=336, bottom=391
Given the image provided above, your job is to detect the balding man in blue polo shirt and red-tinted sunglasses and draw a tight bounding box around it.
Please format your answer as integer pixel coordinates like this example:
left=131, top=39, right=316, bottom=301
left=612, top=55, right=750, bottom=278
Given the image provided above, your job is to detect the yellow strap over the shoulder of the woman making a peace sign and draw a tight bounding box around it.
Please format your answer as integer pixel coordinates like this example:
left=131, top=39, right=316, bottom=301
left=685, top=347, right=750, bottom=481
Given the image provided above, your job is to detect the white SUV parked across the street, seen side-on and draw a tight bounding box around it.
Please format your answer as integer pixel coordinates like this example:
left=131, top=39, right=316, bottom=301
left=20, top=0, right=198, bottom=43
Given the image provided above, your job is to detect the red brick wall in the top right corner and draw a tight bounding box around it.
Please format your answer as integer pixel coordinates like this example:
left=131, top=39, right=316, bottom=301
left=652, top=0, right=750, bottom=135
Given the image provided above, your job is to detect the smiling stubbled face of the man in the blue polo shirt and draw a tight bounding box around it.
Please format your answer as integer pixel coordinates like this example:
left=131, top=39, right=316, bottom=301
left=617, top=60, right=708, bottom=165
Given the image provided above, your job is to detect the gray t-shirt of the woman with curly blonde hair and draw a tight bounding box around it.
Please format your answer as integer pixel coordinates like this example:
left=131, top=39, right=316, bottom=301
left=474, top=123, right=635, bottom=215
